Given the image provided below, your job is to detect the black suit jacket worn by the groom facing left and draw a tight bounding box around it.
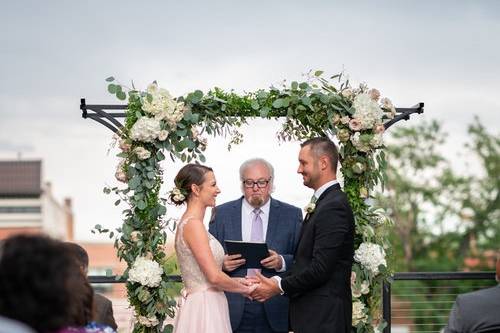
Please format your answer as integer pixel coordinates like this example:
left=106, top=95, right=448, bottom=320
left=281, top=184, right=354, bottom=333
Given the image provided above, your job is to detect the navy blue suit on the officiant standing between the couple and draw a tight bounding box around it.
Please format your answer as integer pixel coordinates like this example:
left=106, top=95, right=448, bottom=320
left=209, top=198, right=302, bottom=332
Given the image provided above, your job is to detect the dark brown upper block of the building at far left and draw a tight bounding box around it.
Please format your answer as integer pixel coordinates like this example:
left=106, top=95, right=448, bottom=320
left=0, top=161, right=42, bottom=198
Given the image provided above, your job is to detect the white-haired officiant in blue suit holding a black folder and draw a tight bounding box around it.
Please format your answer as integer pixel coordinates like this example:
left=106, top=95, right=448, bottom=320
left=209, top=158, right=302, bottom=333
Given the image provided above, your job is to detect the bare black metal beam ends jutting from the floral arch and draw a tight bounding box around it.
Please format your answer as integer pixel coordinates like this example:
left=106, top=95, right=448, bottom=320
left=80, top=98, right=424, bottom=133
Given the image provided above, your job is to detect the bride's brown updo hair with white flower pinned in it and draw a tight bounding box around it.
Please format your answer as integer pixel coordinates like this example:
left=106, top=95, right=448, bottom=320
left=169, top=164, right=213, bottom=206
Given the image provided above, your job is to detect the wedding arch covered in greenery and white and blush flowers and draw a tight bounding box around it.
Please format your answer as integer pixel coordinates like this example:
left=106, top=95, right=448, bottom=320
left=80, top=71, right=424, bottom=333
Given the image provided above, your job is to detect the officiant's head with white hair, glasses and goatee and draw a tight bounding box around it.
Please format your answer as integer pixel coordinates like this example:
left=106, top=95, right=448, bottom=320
left=240, top=158, right=274, bottom=208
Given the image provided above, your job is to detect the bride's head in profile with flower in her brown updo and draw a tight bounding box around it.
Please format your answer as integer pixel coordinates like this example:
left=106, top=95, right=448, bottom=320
left=170, top=164, right=220, bottom=207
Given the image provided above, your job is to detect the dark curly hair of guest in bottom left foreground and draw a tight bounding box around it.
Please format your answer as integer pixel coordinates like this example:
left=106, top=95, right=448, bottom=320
left=0, top=235, right=93, bottom=333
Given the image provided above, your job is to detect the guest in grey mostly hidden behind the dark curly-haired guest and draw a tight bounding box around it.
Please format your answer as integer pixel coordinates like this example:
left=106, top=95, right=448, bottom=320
left=64, top=242, right=117, bottom=330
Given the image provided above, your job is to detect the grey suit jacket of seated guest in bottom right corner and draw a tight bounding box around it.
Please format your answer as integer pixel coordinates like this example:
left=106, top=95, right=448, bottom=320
left=444, top=285, right=500, bottom=333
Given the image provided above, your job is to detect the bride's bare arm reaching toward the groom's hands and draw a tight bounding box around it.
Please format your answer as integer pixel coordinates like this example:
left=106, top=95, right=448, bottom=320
left=183, top=219, right=251, bottom=294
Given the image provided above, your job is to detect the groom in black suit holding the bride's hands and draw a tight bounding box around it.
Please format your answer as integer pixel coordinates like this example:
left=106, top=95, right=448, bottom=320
left=252, top=138, right=354, bottom=333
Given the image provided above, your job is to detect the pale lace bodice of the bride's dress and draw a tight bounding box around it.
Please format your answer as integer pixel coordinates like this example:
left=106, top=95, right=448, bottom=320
left=175, top=217, right=224, bottom=294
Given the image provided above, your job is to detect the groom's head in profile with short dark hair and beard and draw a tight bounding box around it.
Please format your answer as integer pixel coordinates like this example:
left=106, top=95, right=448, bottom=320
left=297, top=137, right=339, bottom=190
